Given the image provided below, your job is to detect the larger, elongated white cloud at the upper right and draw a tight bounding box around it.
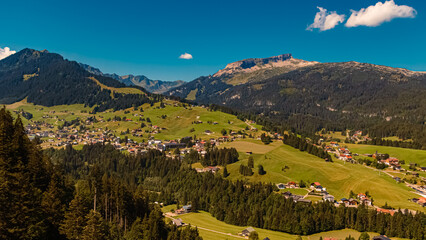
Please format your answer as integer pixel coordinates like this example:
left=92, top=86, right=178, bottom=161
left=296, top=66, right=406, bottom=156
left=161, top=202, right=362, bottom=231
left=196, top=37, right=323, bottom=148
left=345, top=0, right=417, bottom=27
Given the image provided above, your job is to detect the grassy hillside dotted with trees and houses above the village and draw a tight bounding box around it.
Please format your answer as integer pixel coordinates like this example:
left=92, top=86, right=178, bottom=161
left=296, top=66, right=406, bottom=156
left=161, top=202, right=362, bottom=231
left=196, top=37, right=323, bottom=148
left=6, top=100, right=260, bottom=148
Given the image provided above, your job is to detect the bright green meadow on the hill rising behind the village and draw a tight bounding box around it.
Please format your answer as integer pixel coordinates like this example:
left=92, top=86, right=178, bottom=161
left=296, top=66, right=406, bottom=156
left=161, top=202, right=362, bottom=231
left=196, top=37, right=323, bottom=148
left=7, top=100, right=260, bottom=142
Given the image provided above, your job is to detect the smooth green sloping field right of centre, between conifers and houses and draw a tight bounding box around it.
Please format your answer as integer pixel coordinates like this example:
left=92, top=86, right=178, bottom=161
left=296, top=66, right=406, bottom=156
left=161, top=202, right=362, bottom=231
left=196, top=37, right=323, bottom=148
left=223, top=141, right=424, bottom=211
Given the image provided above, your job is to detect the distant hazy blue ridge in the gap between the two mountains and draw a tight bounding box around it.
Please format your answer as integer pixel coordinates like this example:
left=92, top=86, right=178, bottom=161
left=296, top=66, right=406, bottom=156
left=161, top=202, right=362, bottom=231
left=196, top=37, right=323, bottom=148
left=80, top=63, right=185, bottom=94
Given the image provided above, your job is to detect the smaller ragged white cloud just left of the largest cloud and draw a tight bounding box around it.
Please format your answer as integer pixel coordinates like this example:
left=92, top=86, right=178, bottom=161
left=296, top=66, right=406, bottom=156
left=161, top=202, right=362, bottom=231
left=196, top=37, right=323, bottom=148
left=306, top=7, right=346, bottom=31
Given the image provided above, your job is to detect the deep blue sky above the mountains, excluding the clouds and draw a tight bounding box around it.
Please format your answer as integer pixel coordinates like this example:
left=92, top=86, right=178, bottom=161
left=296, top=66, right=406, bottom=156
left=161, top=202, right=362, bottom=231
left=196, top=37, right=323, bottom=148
left=0, top=0, right=426, bottom=81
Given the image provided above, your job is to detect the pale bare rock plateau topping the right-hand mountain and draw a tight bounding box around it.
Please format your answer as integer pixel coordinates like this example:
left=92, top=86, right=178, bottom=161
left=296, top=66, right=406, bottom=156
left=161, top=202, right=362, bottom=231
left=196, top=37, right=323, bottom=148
left=213, top=53, right=317, bottom=77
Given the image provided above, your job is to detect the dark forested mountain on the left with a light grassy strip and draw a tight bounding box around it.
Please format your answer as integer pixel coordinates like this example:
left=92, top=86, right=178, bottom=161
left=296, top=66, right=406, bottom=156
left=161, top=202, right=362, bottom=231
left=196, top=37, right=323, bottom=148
left=0, top=49, right=159, bottom=111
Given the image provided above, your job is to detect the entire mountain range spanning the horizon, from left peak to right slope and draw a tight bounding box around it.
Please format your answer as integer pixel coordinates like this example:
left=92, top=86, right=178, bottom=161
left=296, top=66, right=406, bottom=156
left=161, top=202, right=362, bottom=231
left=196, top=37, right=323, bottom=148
left=0, top=49, right=426, bottom=146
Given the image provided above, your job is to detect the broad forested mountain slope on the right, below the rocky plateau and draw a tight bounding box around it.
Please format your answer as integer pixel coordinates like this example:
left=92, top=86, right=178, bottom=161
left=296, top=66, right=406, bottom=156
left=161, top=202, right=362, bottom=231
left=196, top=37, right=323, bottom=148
left=167, top=55, right=426, bottom=146
